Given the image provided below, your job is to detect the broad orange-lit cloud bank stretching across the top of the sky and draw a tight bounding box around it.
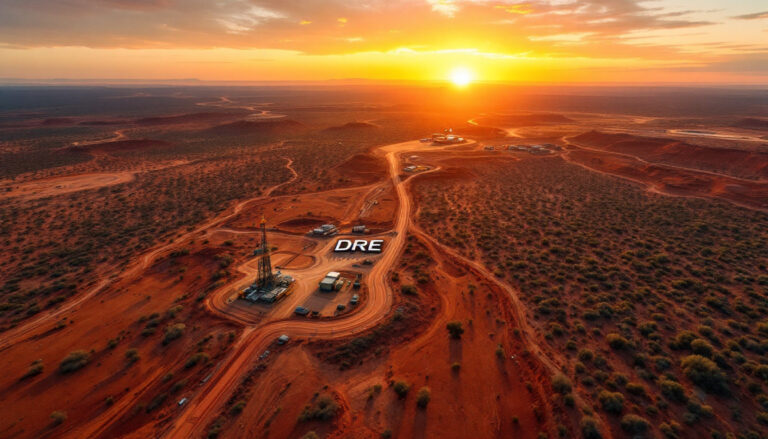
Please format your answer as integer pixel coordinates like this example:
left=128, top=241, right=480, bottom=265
left=0, top=0, right=749, bottom=69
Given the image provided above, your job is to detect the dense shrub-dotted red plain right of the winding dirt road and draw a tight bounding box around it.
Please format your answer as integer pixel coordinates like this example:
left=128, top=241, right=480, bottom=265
left=414, top=158, right=768, bottom=434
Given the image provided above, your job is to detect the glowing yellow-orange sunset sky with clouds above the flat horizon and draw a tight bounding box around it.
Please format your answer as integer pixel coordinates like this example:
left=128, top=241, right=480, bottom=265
left=0, top=0, right=768, bottom=84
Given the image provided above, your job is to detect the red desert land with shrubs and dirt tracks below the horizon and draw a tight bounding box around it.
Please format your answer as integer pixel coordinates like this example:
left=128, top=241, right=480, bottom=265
left=0, top=89, right=768, bottom=439
